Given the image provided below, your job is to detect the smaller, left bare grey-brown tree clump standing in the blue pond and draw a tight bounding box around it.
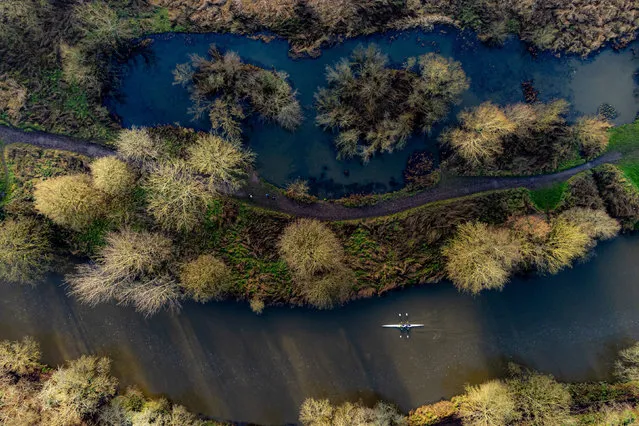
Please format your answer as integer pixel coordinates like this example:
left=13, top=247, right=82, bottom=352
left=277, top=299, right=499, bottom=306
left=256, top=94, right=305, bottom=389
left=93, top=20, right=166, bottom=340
left=173, top=45, right=302, bottom=133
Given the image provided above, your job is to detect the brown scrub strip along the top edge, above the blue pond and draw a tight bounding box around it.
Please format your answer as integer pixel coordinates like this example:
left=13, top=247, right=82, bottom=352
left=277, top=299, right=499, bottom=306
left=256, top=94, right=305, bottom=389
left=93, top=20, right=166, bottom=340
left=151, top=0, right=639, bottom=55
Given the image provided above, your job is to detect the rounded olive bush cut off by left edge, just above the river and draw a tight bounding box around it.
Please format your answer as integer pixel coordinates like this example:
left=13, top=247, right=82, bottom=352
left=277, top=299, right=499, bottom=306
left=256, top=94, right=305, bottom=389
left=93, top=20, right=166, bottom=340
left=0, top=218, right=52, bottom=284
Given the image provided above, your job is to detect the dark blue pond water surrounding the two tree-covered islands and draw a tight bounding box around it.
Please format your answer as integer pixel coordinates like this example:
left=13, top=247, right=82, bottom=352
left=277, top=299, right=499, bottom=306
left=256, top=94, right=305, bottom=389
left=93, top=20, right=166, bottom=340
left=107, top=28, right=639, bottom=197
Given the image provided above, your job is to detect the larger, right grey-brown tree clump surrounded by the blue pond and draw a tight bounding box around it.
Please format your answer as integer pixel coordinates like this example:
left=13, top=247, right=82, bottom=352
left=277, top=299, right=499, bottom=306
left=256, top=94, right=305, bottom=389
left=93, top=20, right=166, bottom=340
left=315, top=45, right=468, bottom=161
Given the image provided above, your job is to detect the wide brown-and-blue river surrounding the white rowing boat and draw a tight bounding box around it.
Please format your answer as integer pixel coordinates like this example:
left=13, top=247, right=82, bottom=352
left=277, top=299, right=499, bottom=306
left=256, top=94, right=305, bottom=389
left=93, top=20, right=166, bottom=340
left=0, top=237, right=639, bottom=423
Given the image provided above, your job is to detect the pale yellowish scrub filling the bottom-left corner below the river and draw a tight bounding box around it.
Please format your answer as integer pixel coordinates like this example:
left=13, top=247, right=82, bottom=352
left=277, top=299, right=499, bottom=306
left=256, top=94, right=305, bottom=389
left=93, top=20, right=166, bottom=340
left=0, top=338, right=224, bottom=426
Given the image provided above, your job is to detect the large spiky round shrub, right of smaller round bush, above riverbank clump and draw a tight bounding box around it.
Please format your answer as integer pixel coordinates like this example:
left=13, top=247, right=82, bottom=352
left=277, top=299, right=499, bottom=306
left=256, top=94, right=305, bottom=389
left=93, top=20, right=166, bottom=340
left=143, top=160, right=213, bottom=232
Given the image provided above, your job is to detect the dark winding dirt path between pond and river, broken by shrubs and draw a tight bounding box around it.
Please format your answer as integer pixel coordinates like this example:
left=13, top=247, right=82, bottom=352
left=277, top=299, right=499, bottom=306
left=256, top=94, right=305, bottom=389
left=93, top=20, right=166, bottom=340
left=0, top=126, right=622, bottom=220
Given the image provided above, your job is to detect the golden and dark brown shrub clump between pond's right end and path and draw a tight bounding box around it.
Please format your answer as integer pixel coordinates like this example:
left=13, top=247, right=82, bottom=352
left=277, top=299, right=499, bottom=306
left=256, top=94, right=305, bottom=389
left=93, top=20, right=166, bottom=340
left=441, top=100, right=595, bottom=175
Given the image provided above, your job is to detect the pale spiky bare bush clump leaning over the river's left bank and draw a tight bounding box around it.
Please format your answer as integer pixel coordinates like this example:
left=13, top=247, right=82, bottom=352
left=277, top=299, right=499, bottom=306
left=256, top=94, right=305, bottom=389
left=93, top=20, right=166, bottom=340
left=67, top=230, right=180, bottom=315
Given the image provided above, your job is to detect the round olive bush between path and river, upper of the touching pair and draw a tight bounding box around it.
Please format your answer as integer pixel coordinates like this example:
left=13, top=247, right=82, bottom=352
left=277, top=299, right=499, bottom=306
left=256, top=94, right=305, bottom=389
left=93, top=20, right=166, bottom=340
left=279, top=219, right=344, bottom=278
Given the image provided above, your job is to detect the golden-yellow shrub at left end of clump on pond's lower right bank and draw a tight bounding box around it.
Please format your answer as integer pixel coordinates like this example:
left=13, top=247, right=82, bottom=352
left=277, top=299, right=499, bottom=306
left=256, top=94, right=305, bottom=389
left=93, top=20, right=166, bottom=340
left=443, top=102, right=516, bottom=167
